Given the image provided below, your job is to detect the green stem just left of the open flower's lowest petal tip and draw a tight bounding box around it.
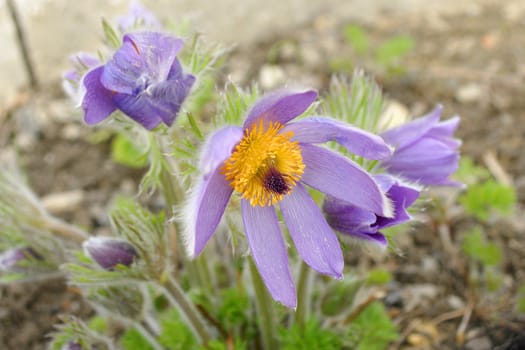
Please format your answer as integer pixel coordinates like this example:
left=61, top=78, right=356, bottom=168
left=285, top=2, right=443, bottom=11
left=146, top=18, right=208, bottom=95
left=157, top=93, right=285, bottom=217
left=249, top=259, right=278, bottom=350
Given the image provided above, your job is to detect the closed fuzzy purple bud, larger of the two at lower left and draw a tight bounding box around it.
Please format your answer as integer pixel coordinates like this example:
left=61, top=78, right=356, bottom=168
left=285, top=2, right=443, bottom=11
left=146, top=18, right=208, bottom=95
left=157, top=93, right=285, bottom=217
left=82, top=237, right=138, bottom=271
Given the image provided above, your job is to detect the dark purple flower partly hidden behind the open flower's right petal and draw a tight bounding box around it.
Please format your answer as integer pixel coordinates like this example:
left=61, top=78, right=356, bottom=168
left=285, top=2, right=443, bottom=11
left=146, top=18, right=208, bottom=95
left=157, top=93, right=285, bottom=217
left=323, top=174, right=420, bottom=250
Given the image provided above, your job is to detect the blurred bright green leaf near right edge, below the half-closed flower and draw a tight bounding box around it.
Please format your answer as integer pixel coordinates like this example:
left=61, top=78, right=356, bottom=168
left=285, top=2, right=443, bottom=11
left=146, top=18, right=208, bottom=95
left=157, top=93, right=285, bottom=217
left=459, top=179, right=516, bottom=221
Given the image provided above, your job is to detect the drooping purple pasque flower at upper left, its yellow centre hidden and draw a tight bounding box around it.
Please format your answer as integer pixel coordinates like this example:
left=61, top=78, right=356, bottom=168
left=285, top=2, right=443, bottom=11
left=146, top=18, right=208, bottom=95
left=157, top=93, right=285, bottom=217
left=82, top=32, right=195, bottom=130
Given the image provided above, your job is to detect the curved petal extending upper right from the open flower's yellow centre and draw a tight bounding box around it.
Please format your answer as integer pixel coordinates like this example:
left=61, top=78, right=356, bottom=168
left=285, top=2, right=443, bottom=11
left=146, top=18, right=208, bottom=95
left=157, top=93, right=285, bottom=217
left=283, top=117, right=392, bottom=159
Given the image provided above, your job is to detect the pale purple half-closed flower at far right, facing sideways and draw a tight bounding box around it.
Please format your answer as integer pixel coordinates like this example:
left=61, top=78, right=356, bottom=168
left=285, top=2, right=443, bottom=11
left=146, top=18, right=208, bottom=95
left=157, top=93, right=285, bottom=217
left=381, top=106, right=461, bottom=186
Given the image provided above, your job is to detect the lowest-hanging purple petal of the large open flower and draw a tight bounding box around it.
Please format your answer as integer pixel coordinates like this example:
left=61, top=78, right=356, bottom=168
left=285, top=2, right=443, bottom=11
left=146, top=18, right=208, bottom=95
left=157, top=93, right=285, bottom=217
left=241, top=199, right=297, bottom=308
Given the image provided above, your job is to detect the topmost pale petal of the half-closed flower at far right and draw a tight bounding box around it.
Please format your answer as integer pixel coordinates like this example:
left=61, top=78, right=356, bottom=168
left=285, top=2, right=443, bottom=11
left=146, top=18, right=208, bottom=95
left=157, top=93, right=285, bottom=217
left=381, top=105, right=443, bottom=149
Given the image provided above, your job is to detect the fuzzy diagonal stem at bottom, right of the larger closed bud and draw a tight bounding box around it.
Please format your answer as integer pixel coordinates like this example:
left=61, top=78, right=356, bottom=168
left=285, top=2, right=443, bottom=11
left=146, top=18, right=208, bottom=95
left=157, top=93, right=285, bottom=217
left=162, top=276, right=212, bottom=345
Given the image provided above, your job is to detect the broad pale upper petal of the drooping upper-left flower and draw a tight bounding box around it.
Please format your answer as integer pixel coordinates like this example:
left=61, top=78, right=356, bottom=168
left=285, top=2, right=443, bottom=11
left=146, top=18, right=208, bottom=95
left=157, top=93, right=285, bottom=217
left=102, top=32, right=183, bottom=94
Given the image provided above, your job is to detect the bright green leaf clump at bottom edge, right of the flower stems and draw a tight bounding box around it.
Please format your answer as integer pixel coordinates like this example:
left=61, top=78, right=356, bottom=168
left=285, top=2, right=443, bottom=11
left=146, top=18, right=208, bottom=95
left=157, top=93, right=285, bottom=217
left=349, top=301, right=399, bottom=350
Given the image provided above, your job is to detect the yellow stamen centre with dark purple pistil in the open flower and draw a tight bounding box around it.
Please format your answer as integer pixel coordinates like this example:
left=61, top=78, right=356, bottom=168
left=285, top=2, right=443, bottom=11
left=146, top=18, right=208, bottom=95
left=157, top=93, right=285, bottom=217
left=222, top=119, right=304, bottom=207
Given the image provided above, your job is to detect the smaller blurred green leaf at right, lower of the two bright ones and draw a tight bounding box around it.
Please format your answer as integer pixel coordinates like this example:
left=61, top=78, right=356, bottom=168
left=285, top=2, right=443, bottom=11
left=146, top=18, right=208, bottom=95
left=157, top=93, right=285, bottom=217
left=462, top=227, right=502, bottom=266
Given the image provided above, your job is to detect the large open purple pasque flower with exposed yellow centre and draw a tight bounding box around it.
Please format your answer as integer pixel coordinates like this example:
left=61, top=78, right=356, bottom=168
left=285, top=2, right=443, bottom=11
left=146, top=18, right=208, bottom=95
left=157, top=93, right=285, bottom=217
left=184, top=90, right=392, bottom=308
